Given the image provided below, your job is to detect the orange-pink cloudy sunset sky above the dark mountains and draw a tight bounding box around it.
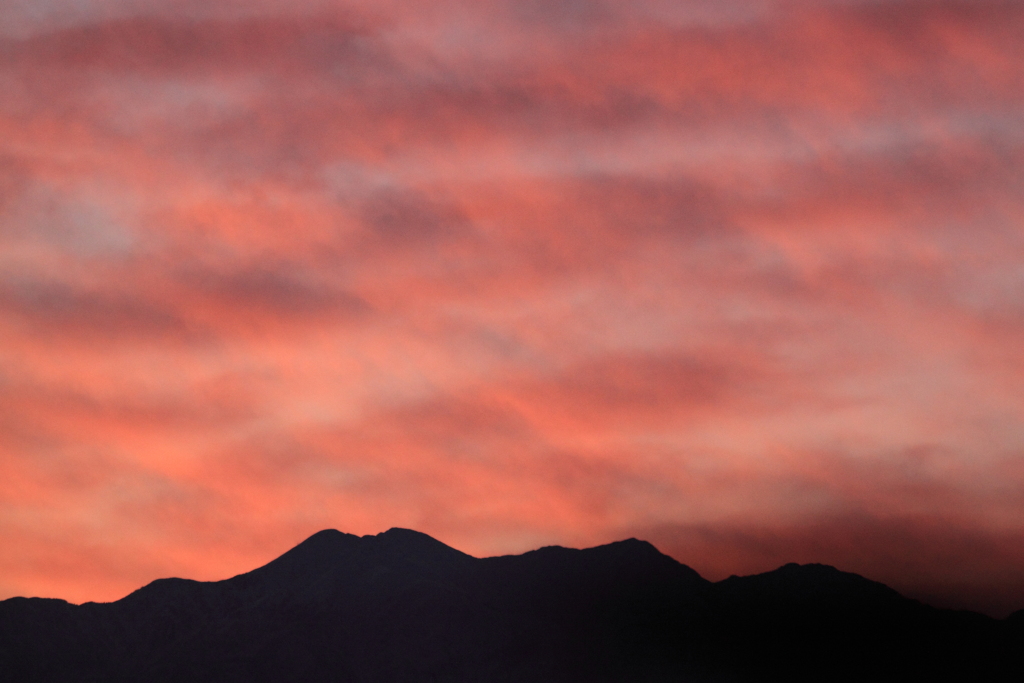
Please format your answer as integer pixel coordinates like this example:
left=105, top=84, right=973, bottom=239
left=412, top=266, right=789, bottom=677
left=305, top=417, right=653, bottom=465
left=0, top=0, right=1024, bottom=615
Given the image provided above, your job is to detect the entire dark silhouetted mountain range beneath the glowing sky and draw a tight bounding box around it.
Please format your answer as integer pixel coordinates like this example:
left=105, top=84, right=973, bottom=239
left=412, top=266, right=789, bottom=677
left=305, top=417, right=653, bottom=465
left=0, top=528, right=1024, bottom=683
